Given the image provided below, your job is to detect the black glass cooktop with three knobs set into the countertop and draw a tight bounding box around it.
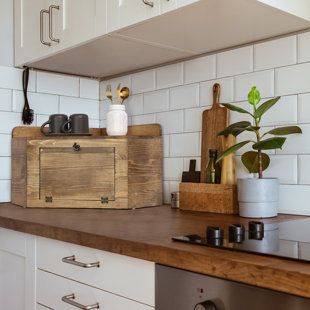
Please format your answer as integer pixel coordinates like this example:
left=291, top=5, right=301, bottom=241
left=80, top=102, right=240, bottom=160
left=172, top=218, right=310, bottom=262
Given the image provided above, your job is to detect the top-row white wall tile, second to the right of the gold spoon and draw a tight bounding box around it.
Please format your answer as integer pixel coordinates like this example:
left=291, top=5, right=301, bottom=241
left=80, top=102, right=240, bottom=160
left=156, top=63, right=183, bottom=89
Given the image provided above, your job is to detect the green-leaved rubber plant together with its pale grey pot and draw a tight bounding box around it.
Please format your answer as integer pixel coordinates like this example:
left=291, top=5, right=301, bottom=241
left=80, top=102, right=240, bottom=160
left=217, top=86, right=302, bottom=218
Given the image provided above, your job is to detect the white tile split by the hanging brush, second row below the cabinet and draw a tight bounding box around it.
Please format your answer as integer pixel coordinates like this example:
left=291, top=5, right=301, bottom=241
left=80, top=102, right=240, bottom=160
left=13, top=90, right=59, bottom=114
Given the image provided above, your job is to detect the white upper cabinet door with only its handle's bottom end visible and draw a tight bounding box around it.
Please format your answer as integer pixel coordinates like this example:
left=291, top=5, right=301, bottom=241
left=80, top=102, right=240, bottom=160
left=107, top=0, right=160, bottom=32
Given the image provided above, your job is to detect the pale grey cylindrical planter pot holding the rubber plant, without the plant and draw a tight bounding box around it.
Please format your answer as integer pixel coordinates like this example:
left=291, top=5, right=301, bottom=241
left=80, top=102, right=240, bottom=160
left=238, top=179, right=279, bottom=218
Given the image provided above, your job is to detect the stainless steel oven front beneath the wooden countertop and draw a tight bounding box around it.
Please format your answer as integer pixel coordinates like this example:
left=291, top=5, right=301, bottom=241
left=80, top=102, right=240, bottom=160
left=156, top=265, right=310, bottom=310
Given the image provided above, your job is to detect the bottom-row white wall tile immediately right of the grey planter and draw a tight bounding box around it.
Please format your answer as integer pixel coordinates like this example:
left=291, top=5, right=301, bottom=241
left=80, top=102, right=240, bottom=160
left=279, top=185, right=310, bottom=215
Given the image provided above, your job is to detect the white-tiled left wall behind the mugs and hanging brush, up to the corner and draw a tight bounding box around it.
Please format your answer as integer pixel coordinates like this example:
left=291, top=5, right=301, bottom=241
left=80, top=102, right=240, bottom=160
left=0, top=0, right=99, bottom=202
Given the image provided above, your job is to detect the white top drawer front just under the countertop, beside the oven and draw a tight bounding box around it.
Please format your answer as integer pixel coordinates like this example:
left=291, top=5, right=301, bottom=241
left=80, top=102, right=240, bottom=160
left=37, top=238, right=155, bottom=306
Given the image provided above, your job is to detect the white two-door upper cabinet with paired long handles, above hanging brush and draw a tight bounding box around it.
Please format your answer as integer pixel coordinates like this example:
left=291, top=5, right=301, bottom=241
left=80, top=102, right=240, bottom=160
left=15, top=0, right=100, bottom=66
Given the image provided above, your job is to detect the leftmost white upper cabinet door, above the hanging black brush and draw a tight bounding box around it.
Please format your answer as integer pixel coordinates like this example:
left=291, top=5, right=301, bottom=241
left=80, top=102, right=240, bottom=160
left=14, top=0, right=53, bottom=66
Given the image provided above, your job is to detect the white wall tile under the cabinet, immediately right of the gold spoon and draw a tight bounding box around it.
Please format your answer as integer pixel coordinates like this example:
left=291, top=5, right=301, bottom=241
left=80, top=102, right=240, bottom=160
left=131, top=70, right=155, bottom=94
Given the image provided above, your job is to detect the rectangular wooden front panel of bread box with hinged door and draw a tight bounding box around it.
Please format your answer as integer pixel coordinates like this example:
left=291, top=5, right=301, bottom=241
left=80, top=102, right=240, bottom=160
left=27, top=139, right=128, bottom=208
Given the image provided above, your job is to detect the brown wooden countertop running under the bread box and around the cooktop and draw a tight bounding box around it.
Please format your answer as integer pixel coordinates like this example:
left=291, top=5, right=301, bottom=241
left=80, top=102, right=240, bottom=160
left=0, top=203, right=310, bottom=298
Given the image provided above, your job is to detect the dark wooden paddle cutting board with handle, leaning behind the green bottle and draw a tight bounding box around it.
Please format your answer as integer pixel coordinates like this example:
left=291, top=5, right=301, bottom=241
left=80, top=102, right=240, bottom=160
left=200, top=83, right=229, bottom=183
